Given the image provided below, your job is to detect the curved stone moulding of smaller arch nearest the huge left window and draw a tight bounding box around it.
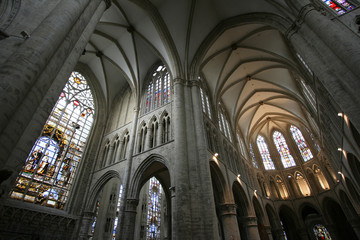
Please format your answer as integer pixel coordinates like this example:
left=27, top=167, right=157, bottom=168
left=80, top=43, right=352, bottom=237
left=85, top=170, right=122, bottom=212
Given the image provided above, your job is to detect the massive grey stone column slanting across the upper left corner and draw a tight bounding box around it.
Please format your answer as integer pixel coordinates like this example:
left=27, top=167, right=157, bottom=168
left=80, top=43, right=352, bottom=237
left=0, top=0, right=105, bottom=166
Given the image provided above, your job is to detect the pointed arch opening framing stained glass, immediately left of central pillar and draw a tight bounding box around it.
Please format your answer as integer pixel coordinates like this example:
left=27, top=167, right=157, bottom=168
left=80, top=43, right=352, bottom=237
left=126, top=155, right=172, bottom=239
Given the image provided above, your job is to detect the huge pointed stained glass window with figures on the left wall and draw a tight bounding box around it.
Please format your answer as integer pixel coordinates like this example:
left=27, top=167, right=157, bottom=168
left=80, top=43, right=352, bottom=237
left=10, top=72, right=94, bottom=209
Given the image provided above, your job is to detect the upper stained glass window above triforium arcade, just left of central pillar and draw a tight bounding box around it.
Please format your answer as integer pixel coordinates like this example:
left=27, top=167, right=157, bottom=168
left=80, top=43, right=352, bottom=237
left=144, top=65, right=171, bottom=113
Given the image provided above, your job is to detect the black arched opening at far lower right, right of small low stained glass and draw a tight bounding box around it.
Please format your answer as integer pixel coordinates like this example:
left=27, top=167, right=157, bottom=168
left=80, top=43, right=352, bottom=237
left=323, top=198, right=358, bottom=240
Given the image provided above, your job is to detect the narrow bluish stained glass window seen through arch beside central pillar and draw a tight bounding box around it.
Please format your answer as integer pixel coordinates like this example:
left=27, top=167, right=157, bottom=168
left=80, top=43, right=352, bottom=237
left=146, top=177, right=161, bottom=240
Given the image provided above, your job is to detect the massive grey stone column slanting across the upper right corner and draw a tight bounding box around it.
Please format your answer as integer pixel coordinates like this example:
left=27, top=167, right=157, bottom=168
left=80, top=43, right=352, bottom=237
left=286, top=0, right=360, bottom=129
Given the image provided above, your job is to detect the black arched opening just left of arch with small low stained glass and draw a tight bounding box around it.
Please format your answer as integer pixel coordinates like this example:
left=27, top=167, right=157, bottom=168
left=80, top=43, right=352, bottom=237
left=279, top=206, right=300, bottom=240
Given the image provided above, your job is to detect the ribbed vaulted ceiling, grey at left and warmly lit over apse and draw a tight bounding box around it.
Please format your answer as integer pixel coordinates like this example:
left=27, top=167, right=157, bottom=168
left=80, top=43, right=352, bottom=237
left=80, top=0, right=316, bottom=144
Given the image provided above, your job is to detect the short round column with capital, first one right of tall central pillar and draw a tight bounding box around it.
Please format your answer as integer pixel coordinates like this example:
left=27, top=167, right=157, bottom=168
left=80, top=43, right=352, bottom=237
left=220, top=203, right=240, bottom=240
